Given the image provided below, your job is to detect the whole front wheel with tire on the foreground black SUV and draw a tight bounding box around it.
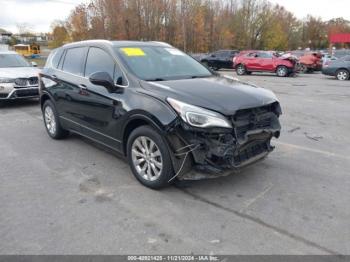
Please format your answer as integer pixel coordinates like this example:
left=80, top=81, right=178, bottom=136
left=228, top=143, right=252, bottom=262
left=127, top=126, right=175, bottom=189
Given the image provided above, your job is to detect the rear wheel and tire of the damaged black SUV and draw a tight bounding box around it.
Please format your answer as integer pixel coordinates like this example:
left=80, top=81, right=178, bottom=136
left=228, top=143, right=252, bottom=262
left=42, top=100, right=69, bottom=139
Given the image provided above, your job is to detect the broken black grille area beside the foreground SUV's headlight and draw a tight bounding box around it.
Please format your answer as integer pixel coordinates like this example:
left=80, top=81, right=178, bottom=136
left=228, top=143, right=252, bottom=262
left=232, top=104, right=278, bottom=140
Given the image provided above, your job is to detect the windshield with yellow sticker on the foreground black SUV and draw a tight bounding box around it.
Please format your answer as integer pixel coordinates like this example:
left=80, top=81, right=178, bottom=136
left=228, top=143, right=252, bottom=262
left=116, top=46, right=213, bottom=81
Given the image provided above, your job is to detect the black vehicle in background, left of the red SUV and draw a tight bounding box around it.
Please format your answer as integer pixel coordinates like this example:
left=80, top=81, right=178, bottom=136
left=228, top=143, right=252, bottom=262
left=200, top=50, right=238, bottom=70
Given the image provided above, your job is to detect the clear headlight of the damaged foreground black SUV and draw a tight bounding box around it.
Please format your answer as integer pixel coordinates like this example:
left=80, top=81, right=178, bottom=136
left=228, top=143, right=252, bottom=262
left=167, top=98, right=232, bottom=128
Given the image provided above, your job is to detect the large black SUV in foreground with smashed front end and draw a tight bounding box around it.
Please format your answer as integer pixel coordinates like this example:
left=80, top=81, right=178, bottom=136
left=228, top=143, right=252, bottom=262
left=39, top=40, right=281, bottom=188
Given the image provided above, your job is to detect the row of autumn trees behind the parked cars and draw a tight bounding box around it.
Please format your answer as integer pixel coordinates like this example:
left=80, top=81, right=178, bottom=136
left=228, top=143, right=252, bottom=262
left=50, top=0, right=350, bottom=53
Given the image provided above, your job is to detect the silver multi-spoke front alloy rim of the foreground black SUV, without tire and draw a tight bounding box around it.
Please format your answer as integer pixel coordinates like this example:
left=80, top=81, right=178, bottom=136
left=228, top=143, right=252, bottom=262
left=131, top=136, right=163, bottom=181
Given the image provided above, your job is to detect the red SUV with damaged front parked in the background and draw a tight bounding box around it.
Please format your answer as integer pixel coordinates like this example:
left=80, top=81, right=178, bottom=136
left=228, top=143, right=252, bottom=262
left=233, top=51, right=297, bottom=77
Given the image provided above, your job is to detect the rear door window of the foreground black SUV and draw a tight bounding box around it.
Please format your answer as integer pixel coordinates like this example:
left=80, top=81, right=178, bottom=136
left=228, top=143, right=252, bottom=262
left=62, top=47, right=87, bottom=76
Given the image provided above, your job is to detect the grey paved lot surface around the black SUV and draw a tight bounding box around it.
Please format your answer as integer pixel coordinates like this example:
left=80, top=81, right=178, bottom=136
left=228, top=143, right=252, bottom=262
left=0, top=71, right=350, bottom=254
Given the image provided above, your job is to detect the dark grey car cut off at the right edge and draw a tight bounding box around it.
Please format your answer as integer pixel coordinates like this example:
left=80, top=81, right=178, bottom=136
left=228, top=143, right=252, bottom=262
left=322, top=55, right=350, bottom=81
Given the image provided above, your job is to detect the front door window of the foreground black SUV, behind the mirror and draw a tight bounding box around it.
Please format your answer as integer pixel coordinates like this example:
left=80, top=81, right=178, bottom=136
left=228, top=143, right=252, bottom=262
left=85, top=47, right=115, bottom=78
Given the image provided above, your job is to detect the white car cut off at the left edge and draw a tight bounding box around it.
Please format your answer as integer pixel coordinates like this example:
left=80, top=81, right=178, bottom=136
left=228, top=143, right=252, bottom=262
left=0, top=51, right=40, bottom=101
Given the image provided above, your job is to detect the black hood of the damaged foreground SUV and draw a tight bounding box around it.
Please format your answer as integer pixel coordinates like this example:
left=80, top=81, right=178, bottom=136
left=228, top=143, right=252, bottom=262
left=141, top=77, right=278, bottom=115
